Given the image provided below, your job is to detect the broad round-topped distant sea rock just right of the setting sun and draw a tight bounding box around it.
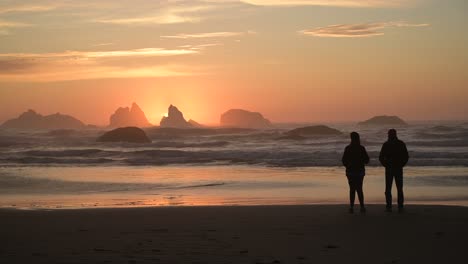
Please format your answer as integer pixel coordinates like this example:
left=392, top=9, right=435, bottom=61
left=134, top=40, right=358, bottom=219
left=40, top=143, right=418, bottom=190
left=220, top=109, right=272, bottom=129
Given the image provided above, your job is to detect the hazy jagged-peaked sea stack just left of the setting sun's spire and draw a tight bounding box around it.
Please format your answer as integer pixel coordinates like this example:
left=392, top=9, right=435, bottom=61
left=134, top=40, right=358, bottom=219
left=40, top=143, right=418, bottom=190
left=109, top=103, right=152, bottom=127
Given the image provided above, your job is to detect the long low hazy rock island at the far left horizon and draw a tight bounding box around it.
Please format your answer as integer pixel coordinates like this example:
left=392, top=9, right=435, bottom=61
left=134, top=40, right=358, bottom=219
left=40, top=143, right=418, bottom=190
left=0, top=110, right=86, bottom=130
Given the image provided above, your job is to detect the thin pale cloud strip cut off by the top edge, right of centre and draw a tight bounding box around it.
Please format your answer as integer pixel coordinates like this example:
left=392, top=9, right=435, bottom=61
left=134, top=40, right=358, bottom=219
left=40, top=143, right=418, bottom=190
left=234, top=0, right=418, bottom=7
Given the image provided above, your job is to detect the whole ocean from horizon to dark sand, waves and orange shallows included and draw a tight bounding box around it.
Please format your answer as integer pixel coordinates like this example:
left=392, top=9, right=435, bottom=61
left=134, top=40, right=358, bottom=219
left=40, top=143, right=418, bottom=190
left=0, top=122, right=468, bottom=209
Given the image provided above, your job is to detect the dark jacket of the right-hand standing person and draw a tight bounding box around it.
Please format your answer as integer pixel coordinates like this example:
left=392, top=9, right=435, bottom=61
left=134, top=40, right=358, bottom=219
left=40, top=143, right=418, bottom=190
left=379, top=139, right=409, bottom=168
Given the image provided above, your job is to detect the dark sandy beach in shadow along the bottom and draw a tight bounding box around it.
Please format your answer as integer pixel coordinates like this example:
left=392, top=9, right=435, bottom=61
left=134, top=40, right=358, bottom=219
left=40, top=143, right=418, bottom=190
left=0, top=205, right=468, bottom=263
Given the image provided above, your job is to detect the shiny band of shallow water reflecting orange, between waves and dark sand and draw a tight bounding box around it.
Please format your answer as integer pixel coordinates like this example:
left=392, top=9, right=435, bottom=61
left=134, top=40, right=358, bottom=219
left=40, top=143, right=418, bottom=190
left=0, top=166, right=468, bottom=208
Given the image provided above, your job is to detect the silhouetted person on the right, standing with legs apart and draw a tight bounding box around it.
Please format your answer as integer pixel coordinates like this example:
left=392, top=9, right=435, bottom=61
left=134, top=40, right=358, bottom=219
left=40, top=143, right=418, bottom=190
left=379, top=129, right=409, bottom=212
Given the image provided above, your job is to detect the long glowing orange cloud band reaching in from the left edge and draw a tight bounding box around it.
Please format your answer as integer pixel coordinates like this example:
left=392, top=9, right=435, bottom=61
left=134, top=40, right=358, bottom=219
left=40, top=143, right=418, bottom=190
left=0, top=47, right=208, bottom=82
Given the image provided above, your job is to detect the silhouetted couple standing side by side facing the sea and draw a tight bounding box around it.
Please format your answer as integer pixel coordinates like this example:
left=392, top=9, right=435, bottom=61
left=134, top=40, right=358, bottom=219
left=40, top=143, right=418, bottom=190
left=342, top=129, right=409, bottom=213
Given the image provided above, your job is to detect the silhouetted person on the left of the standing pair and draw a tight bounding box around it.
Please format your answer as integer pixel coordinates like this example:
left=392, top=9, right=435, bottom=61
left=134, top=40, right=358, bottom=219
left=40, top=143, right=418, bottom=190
left=341, top=132, right=369, bottom=213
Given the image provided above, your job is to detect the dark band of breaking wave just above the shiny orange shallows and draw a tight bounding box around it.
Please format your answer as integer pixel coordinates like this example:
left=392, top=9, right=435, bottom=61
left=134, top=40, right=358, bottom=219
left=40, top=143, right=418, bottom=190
left=0, top=147, right=468, bottom=167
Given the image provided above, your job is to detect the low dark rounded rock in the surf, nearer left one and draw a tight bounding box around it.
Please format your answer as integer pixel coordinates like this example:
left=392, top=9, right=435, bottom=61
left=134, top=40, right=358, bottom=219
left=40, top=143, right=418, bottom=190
left=97, top=127, right=151, bottom=143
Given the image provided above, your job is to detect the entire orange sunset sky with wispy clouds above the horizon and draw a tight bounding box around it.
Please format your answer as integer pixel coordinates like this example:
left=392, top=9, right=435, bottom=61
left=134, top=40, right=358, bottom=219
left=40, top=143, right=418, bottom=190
left=0, top=0, right=468, bottom=125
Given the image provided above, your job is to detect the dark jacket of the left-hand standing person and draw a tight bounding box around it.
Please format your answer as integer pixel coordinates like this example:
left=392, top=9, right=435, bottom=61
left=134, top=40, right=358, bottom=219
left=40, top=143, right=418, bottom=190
left=341, top=144, right=369, bottom=174
